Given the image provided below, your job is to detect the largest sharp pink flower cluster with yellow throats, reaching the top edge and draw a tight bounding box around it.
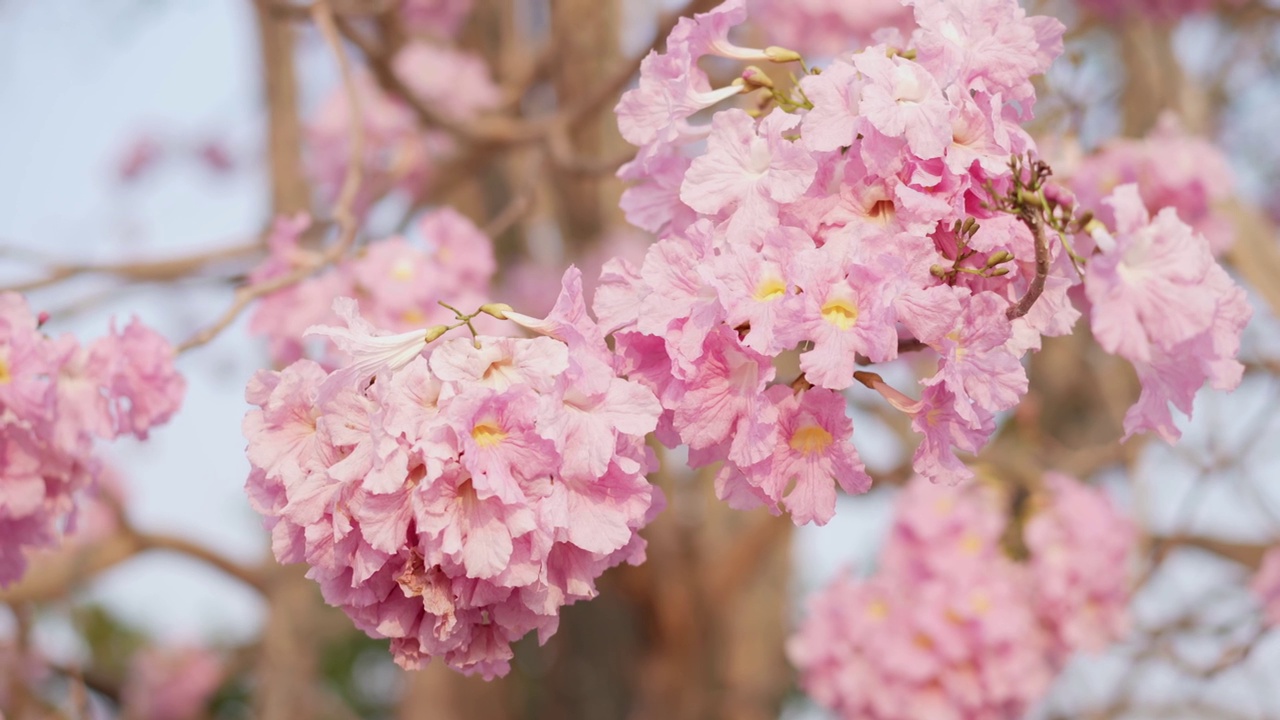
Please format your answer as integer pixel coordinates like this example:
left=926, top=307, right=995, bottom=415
left=595, top=0, right=1248, bottom=509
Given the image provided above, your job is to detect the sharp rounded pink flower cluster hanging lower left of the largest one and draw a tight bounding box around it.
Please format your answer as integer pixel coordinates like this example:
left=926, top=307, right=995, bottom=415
left=244, top=269, right=662, bottom=678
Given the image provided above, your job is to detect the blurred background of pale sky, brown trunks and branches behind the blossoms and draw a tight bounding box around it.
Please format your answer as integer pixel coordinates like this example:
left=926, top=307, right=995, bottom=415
left=0, top=0, right=1280, bottom=720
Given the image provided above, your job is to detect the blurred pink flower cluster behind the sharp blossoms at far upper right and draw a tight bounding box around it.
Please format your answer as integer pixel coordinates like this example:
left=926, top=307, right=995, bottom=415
left=1068, top=113, right=1235, bottom=255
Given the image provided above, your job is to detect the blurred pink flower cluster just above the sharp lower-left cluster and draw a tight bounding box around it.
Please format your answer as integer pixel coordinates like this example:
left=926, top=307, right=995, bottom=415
left=250, top=208, right=497, bottom=368
